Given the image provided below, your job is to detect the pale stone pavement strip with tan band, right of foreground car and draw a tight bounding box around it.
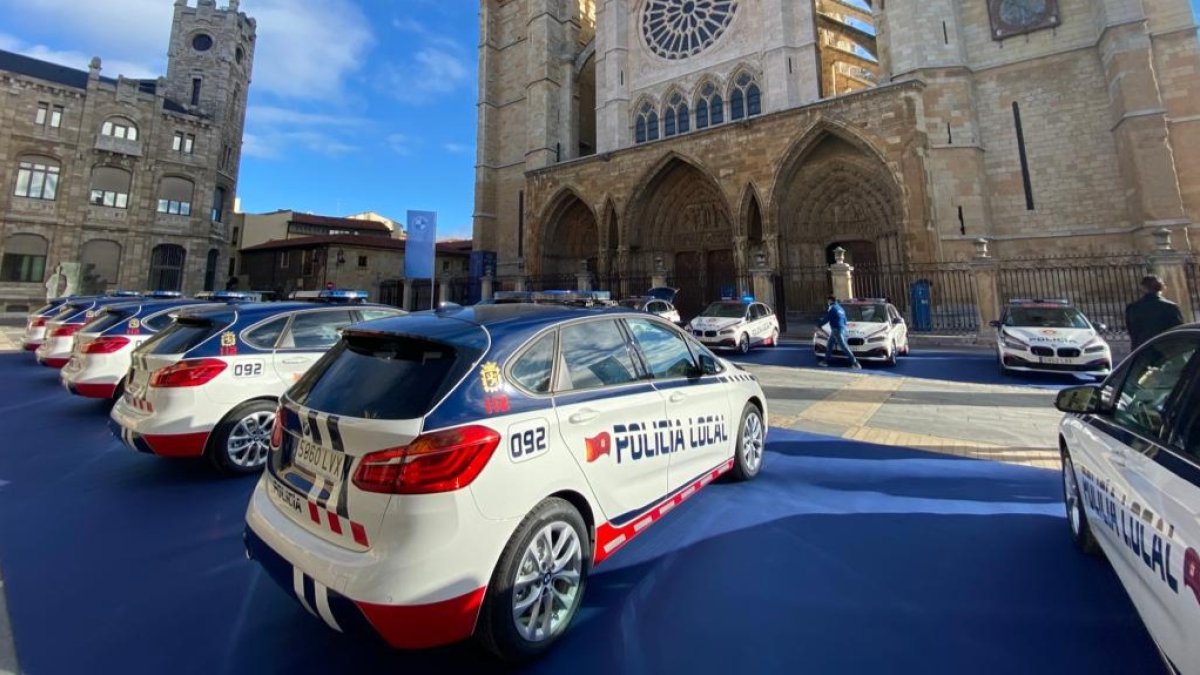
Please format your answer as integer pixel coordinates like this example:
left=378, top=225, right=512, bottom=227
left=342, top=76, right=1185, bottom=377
left=745, top=364, right=1062, bottom=470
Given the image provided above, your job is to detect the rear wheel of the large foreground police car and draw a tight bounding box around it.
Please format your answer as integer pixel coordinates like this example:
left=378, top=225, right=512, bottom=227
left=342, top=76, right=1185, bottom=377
left=475, top=497, right=593, bottom=663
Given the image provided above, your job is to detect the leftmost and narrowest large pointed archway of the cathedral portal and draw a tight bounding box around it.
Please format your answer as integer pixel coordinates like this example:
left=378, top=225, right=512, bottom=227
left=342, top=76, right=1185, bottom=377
left=538, top=191, right=600, bottom=281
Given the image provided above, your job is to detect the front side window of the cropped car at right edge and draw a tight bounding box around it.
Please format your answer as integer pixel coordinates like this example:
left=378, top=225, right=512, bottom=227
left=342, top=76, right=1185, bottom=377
left=1112, top=335, right=1196, bottom=438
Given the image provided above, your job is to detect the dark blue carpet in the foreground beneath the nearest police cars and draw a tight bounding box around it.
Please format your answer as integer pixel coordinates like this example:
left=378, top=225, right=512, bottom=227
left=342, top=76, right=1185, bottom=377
left=0, top=354, right=1158, bottom=675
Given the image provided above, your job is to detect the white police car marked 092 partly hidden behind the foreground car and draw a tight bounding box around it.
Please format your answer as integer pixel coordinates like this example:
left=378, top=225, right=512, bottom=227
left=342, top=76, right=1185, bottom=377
left=109, top=292, right=404, bottom=473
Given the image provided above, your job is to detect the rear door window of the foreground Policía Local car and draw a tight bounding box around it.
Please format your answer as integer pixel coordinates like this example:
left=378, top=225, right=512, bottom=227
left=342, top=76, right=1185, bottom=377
left=559, top=321, right=637, bottom=390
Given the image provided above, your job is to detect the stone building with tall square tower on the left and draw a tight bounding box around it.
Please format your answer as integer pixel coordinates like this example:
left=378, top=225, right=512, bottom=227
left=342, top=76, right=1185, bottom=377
left=0, top=0, right=256, bottom=311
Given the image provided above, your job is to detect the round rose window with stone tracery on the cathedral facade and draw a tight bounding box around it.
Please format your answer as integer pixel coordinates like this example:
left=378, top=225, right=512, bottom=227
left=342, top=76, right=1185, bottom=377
left=642, top=0, right=738, bottom=60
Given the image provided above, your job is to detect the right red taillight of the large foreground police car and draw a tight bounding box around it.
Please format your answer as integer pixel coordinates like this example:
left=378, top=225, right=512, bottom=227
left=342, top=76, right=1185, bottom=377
left=354, top=426, right=500, bottom=495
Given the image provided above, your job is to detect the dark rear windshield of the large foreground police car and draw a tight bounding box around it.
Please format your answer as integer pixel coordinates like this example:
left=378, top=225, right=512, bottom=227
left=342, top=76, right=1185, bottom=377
left=289, top=335, right=478, bottom=419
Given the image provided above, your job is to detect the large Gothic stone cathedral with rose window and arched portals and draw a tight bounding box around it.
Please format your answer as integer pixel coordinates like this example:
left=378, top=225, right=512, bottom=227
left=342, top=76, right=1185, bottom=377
left=474, top=0, right=1200, bottom=317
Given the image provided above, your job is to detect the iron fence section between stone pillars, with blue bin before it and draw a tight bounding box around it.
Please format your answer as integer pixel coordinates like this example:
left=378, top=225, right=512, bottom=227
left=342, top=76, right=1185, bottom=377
left=854, top=263, right=979, bottom=334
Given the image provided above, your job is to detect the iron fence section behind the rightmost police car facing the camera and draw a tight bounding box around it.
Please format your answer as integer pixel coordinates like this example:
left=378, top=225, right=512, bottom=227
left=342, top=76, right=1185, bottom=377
left=996, top=256, right=1150, bottom=335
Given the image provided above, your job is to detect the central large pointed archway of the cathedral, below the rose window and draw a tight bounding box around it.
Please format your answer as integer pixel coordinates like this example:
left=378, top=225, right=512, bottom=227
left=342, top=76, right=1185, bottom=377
left=625, top=156, right=740, bottom=316
